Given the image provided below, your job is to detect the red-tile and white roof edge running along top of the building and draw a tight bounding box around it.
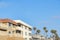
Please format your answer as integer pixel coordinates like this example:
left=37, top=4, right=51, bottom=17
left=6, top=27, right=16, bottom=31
left=0, top=18, right=32, bottom=28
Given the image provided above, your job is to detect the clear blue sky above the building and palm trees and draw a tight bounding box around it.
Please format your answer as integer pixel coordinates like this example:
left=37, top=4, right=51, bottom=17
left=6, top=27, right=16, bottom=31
left=0, top=0, right=60, bottom=35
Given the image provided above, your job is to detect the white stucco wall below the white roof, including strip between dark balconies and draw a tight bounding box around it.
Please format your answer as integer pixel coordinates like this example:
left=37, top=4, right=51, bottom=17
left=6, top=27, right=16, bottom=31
left=16, top=25, right=31, bottom=40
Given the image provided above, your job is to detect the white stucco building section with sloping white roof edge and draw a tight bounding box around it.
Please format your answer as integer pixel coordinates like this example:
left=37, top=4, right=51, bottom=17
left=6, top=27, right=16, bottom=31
left=14, top=20, right=32, bottom=40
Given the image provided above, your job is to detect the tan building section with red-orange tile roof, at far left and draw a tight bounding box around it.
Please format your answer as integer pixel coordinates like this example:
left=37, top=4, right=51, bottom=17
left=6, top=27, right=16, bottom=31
left=0, top=19, right=17, bottom=36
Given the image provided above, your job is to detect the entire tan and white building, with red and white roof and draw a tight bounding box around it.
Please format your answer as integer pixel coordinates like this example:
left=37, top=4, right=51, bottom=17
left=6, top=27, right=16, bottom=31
left=0, top=19, right=32, bottom=40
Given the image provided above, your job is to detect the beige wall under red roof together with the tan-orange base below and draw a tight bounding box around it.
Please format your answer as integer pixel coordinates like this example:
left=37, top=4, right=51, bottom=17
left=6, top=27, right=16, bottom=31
left=0, top=23, right=24, bottom=40
